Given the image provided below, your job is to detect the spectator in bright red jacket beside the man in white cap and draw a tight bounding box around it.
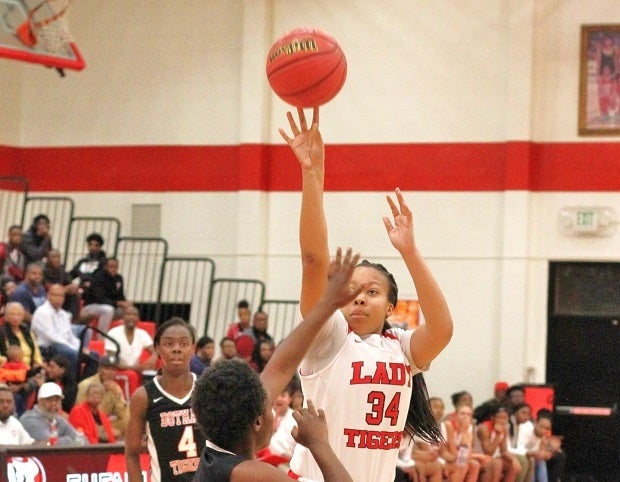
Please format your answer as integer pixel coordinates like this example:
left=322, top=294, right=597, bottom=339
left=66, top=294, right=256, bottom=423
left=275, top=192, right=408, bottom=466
left=69, top=383, right=116, bottom=444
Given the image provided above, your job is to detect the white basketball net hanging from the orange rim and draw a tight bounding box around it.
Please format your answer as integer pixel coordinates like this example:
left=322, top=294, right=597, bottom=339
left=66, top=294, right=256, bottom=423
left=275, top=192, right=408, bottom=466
left=17, top=0, right=73, bottom=54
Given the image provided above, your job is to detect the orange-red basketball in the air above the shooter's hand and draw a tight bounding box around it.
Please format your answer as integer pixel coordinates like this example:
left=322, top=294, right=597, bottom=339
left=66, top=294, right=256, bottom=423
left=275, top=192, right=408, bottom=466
left=267, top=28, right=347, bottom=107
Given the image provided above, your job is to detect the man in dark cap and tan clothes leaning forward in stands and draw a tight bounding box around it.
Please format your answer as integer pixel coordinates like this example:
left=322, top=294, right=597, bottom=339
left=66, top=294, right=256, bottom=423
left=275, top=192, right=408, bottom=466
left=75, top=355, right=129, bottom=439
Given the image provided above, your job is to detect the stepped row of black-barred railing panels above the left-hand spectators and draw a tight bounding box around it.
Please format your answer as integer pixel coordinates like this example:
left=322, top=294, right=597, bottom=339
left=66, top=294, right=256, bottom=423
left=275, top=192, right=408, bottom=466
left=0, top=177, right=298, bottom=342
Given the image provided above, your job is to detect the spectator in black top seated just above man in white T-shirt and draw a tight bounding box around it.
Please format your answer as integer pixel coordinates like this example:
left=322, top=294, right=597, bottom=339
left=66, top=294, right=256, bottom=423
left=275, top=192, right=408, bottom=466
left=80, top=258, right=131, bottom=333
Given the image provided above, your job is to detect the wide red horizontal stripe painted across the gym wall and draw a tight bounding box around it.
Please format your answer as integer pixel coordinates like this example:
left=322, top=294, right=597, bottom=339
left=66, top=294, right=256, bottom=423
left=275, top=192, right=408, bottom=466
left=0, top=141, right=620, bottom=192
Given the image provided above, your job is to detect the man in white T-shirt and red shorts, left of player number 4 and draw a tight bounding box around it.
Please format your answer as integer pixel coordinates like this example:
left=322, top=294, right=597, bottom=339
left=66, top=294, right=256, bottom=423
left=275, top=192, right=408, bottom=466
left=105, top=305, right=157, bottom=395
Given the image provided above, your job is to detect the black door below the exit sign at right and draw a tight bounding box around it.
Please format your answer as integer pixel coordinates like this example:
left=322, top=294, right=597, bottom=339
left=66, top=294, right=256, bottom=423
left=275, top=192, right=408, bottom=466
left=547, top=262, right=620, bottom=482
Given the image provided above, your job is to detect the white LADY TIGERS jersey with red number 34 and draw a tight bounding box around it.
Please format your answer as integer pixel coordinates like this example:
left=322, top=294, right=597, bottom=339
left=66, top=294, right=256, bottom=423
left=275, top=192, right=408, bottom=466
left=290, top=311, right=420, bottom=482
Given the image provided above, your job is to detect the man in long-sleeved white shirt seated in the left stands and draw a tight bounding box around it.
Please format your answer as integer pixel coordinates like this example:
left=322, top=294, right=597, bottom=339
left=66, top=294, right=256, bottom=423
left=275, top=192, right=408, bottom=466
left=31, top=285, right=97, bottom=376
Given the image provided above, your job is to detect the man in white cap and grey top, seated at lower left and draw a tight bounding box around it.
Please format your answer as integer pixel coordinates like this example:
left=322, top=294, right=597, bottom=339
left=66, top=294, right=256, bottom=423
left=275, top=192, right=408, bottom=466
left=19, top=382, right=78, bottom=445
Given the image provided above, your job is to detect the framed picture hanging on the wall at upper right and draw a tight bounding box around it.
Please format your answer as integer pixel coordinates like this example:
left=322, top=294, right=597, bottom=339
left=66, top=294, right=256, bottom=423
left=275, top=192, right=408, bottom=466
left=579, top=24, right=620, bottom=136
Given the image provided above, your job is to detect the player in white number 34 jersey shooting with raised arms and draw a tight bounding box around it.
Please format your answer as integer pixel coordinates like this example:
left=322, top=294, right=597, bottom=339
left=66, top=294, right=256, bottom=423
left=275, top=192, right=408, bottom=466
left=280, top=107, right=453, bottom=482
